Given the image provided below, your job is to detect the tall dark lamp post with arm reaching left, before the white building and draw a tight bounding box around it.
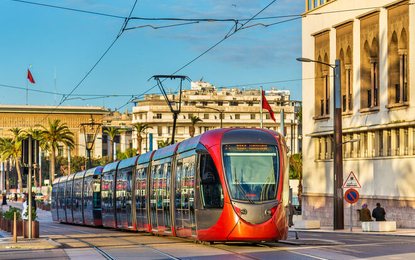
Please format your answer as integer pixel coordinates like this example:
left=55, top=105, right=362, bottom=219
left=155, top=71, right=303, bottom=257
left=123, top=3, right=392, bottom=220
left=297, top=58, right=344, bottom=230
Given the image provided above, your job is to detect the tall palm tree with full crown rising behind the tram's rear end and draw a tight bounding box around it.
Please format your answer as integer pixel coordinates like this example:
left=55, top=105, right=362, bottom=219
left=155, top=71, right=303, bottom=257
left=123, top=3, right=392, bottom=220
left=38, top=119, right=75, bottom=183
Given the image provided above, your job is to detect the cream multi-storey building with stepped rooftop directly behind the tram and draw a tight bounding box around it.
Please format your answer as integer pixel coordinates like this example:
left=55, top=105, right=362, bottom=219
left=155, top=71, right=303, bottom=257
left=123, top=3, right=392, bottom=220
left=132, top=84, right=301, bottom=153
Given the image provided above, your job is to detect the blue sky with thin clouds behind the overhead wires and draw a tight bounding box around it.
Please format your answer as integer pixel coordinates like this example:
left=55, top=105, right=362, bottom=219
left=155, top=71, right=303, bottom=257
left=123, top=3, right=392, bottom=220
left=0, top=0, right=304, bottom=111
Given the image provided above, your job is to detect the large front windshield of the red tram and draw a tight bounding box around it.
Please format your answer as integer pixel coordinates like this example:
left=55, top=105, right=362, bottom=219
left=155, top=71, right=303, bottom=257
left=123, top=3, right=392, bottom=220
left=223, top=144, right=280, bottom=203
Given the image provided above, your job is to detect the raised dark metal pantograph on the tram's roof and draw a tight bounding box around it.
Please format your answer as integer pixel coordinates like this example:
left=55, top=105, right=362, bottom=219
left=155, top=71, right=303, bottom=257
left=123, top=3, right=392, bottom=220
left=149, top=75, right=191, bottom=144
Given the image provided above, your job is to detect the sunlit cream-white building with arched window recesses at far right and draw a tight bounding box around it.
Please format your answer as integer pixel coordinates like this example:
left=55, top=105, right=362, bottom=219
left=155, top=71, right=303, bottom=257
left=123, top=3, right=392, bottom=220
left=302, top=0, right=415, bottom=228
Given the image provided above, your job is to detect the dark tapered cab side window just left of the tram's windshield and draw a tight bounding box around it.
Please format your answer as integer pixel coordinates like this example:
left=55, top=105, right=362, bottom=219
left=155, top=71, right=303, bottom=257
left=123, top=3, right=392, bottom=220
left=200, top=154, right=223, bottom=208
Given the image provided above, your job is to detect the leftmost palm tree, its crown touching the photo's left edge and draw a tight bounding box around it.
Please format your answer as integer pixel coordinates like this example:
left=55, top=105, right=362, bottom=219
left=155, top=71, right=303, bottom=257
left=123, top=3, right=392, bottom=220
left=0, top=137, right=23, bottom=191
